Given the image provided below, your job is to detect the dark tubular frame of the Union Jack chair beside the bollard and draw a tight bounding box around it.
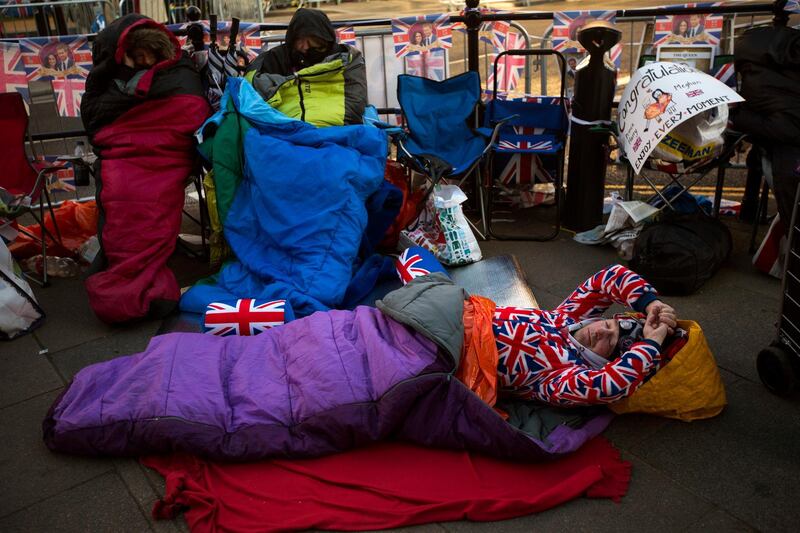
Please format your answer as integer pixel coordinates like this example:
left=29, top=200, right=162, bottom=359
left=481, top=49, right=569, bottom=242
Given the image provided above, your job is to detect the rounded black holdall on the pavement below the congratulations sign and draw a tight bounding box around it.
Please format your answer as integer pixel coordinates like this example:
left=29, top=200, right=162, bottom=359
left=630, top=212, right=733, bottom=295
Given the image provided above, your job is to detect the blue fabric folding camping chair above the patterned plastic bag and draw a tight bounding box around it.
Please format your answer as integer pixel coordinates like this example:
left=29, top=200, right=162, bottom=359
left=394, top=72, right=502, bottom=238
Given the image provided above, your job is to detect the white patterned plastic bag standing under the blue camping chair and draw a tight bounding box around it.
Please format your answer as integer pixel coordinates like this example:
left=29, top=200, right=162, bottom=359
left=433, top=185, right=482, bottom=265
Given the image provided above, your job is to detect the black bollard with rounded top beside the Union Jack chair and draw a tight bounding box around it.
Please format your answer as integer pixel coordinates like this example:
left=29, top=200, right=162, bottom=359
left=564, top=21, right=622, bottom=232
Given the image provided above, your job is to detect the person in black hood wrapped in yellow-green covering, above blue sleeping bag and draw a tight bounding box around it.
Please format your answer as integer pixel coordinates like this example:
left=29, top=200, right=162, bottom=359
left=246, top=8, right=367, bottom=126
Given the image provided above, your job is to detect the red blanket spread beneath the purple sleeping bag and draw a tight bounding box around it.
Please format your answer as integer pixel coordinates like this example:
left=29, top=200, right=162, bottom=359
left=142, top=437, right=630, bottom=533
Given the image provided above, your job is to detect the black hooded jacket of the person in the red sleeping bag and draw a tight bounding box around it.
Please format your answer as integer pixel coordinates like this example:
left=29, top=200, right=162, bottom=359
left=81, top=13, right=205, bottom=138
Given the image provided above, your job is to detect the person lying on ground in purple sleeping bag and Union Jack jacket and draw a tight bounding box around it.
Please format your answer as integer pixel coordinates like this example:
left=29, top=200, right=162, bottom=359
left=44, top=254, right=675, bottom=461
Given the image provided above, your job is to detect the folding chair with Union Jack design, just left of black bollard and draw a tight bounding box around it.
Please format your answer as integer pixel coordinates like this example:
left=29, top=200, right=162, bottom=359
left=482, top=49, right=569, bottom=241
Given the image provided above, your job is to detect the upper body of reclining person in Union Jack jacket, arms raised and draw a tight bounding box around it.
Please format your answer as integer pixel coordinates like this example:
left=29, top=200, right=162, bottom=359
left=493, top=265, right=677, bottom=406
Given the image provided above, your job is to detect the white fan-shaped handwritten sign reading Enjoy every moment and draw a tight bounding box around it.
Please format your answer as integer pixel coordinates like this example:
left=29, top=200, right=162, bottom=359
left=617, top=62, right=744, bottom=173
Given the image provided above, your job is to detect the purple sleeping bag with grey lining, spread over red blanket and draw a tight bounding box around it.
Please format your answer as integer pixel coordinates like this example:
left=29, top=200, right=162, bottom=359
left=44, top=275, right=609, bottom=461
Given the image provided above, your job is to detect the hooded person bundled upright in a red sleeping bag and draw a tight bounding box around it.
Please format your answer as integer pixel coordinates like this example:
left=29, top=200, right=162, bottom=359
left=81, top=14, right=210, bottom=323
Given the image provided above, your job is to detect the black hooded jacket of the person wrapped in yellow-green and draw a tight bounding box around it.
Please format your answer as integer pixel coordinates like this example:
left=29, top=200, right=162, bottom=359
left=247, top=8, right=347, bottom=76
